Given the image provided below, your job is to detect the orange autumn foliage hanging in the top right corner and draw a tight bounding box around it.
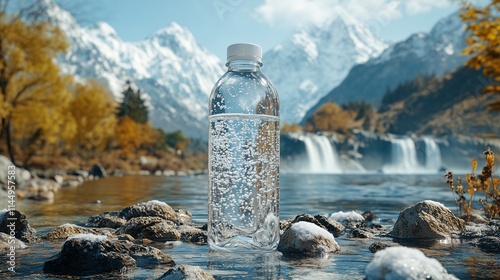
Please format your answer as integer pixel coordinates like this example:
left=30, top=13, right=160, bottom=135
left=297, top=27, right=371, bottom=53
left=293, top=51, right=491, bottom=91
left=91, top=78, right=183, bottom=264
left=460, top=0, right=500, bottom=110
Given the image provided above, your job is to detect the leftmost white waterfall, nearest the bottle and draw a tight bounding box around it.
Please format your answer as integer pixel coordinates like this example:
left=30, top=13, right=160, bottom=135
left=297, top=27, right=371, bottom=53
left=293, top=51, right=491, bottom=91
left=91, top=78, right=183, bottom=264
left=303, top=134, right=342, bottom=173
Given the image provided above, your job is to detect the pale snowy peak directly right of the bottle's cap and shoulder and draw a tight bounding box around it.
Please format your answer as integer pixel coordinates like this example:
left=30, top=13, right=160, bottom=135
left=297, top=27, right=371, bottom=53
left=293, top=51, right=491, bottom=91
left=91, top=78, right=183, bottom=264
left=262, top=10, right=387, bottom=123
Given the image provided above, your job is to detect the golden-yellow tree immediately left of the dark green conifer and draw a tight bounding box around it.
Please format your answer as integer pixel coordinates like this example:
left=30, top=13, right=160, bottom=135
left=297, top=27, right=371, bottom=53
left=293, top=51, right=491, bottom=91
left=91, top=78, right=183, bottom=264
left=68, top=80, right=117, bottom=158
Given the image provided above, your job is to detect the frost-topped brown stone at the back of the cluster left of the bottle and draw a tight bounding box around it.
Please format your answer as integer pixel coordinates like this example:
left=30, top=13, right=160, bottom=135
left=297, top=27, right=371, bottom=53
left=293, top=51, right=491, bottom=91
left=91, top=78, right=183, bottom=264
left=120, top=200, right=178, bottom=221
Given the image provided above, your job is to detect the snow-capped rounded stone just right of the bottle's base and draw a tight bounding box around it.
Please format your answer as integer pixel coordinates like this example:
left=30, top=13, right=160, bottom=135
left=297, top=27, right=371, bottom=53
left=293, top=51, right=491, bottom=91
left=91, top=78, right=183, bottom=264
left=278, top=221, right=340, bottom=258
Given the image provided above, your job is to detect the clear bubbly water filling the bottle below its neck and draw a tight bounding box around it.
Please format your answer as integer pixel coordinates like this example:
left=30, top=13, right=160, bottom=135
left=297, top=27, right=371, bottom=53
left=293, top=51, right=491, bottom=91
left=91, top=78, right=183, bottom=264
left=208, top=114, right=280, bottom=251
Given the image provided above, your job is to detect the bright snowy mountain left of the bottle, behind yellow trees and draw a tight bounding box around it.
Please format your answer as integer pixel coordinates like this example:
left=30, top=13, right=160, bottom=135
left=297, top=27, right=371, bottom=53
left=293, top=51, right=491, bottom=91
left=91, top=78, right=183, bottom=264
left=39, top=0, right=224, bottom=139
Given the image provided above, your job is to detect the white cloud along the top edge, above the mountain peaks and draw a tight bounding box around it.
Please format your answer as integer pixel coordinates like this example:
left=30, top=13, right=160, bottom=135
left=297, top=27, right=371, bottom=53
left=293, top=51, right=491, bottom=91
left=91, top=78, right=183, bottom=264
left=256, top=0, right=451, bottom=27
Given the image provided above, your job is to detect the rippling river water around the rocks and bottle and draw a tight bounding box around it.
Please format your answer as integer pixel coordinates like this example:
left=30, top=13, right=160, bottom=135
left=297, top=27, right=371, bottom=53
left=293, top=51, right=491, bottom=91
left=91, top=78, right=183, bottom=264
left=4, top=174, right=500, bottom=279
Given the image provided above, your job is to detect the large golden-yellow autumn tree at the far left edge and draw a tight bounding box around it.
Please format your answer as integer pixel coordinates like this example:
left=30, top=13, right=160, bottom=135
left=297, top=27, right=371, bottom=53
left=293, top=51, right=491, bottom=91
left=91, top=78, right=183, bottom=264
left=0, top=6, right=71, bottom=163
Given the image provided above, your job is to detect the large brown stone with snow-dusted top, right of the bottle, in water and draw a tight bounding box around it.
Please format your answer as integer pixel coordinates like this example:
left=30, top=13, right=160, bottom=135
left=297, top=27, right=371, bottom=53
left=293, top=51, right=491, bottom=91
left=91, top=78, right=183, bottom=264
left=392, top=200, right=465, bottom=239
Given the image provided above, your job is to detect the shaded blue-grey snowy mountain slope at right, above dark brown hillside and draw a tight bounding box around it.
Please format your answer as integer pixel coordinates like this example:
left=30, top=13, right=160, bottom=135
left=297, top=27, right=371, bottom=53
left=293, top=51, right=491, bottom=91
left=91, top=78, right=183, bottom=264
left=303, top=13, right=467, bottom=121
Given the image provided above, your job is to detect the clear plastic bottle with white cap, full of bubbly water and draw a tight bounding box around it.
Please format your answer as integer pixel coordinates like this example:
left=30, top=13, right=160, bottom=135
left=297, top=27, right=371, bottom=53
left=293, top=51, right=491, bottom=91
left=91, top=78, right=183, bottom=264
left=208, top=44, right=280, bottom=251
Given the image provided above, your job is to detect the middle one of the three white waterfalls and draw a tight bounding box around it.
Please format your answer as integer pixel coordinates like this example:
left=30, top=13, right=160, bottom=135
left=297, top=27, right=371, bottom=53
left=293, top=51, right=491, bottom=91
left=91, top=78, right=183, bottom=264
left=383, top=137, right=421, bottom=173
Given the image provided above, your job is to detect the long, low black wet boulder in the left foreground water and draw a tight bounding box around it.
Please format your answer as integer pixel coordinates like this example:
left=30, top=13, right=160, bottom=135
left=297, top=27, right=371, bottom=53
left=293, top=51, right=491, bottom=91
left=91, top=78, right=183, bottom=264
left=43, top=234, right=175, bottom=275
